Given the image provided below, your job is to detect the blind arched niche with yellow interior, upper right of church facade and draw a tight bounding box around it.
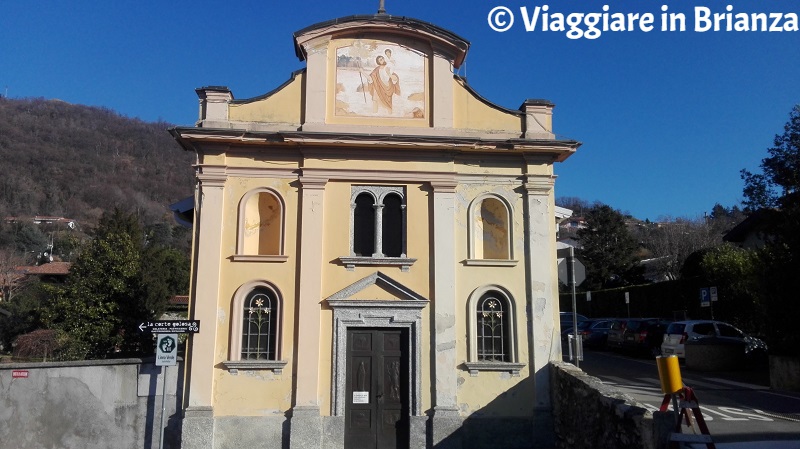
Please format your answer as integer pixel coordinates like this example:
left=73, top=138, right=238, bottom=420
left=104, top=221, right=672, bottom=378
left=467, top=195, right=516, bottom=265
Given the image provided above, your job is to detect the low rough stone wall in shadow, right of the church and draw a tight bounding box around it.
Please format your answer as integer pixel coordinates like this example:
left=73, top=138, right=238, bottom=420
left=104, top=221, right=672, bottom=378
left=551, top=362, right=673, bottom=449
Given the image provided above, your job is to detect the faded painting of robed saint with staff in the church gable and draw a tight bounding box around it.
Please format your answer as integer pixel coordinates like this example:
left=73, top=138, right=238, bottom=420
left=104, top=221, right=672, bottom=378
left=335, top=40, right=426, bottom=118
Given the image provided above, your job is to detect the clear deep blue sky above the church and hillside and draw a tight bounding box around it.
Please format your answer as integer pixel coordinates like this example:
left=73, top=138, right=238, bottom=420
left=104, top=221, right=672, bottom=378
left=0, top=0, right=800, bottom=220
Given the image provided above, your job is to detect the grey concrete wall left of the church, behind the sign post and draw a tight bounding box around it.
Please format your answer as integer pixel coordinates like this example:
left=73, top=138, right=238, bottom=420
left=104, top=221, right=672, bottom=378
left=0, top=359, right=183, bottom=449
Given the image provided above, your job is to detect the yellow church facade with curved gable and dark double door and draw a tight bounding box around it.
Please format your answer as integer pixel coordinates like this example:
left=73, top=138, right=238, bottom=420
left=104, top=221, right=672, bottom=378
left=171, top=14, right=579, bottom=449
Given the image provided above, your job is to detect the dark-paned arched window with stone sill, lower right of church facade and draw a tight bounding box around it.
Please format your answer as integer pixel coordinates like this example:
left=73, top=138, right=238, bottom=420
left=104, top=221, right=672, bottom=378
left=465, top=285, right=525, bottom=376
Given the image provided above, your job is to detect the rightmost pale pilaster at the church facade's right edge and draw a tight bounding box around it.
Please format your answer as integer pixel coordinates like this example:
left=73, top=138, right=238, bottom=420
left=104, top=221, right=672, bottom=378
left=525, top=175, right=561, bottom=409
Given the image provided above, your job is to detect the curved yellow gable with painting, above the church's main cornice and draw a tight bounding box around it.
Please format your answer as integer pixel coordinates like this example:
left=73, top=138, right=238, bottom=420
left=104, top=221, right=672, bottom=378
left=193, top=14, right=555, bottom=140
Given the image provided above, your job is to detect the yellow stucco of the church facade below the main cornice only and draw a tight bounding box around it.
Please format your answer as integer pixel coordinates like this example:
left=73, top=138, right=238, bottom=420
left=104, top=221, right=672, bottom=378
left=197, top=146, right=550, bottom=416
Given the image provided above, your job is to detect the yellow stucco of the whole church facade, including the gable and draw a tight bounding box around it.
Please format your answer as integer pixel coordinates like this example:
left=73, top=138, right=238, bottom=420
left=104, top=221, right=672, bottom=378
left=188, top=27, right=568, bottom=416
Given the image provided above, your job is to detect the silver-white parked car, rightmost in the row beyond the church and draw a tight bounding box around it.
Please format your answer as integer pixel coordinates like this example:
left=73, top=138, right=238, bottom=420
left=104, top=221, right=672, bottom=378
left=661, top=320, right=767, bottom=359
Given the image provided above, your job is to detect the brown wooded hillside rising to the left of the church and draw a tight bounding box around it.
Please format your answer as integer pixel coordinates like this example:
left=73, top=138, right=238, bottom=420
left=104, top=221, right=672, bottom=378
left=0, top=97, right=194, bottom=228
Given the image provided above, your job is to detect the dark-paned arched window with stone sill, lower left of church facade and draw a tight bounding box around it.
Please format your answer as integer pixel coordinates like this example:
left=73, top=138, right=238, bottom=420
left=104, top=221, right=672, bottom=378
left=224, top=281, right=286, bottom=373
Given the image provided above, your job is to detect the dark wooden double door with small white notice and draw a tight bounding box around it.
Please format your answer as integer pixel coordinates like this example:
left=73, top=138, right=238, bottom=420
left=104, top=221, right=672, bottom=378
left=345, top=328, right=409, bottom=449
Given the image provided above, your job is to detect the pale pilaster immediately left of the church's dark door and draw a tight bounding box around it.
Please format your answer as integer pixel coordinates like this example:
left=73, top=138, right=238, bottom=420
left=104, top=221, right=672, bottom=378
left=290, top=176, right=328, bottom=449
